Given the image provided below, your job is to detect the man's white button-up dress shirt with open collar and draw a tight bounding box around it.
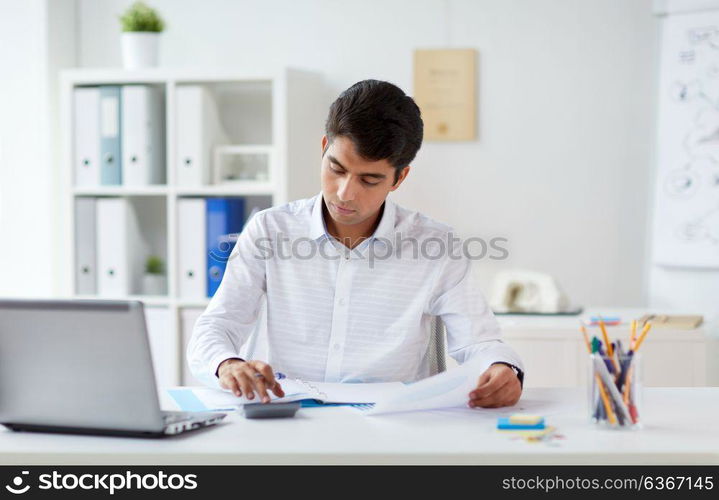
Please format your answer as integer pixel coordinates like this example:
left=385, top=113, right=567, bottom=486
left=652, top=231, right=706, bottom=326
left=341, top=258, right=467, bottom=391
left=187, top=193, right=522, bottom=387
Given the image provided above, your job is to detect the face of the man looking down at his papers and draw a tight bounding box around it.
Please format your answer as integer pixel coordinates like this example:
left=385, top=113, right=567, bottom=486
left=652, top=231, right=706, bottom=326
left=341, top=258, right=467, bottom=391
left=321, top=136, right=409, bottom=225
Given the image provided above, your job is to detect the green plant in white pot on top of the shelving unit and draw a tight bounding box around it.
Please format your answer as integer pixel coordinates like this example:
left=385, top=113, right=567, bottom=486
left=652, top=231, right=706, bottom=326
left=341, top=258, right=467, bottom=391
left=120, top=2, right=165, bottom=69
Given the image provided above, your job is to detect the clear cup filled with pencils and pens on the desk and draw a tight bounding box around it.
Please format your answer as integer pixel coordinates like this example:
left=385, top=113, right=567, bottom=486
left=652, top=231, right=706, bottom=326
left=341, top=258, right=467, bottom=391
left=588, top=353, right=642, bottom=429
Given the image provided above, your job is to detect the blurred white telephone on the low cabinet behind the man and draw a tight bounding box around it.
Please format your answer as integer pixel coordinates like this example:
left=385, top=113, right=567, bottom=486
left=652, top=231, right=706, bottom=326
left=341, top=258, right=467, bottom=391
left=490, top=270, right=569, bottom=314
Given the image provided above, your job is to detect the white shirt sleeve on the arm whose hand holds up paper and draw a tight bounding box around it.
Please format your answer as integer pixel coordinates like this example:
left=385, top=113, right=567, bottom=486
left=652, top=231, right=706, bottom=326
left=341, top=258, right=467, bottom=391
left=428, top=236, right=524, bottom=373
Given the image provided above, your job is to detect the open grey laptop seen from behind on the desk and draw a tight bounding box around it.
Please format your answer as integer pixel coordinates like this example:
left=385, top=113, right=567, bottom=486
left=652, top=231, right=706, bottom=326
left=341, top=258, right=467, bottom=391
left=0, top=300, right=225, bottom=437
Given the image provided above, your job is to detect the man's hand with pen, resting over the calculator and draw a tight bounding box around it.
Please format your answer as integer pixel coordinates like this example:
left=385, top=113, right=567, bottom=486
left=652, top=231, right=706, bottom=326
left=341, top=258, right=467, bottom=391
left=217, top=359, right=285, bottom=403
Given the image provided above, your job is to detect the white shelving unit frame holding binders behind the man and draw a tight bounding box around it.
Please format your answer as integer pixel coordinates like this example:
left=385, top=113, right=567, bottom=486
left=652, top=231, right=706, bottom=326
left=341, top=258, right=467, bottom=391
left=60, top=68, right=329, bottom=385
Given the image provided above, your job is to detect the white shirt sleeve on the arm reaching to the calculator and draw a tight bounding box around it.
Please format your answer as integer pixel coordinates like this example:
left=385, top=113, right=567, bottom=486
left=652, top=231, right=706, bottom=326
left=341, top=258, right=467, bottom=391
left=187, top=213, right=270, bottom=387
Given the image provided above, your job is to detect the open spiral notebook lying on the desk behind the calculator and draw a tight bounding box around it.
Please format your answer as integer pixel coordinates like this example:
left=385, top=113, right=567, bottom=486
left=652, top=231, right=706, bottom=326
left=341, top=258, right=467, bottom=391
left=166, top=378, right=404, bottom=411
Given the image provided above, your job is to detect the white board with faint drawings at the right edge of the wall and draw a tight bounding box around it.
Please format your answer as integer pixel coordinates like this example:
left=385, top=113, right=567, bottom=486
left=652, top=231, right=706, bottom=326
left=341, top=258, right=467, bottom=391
left=653, top=12, right=719, bottom=268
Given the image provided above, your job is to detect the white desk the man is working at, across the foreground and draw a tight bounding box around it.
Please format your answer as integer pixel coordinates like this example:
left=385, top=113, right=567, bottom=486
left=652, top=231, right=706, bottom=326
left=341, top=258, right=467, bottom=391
left=0, top=388, right=719, bottom=465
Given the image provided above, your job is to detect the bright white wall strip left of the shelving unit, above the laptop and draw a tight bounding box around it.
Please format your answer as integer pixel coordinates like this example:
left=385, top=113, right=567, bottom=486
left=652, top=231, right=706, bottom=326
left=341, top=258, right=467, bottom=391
left=0, top=0, right=75, bottom=296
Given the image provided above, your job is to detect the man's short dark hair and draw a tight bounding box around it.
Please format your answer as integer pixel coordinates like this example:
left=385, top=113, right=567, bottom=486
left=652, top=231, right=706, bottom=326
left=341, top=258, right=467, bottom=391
left=325, top=80, right=424, bottom=184
